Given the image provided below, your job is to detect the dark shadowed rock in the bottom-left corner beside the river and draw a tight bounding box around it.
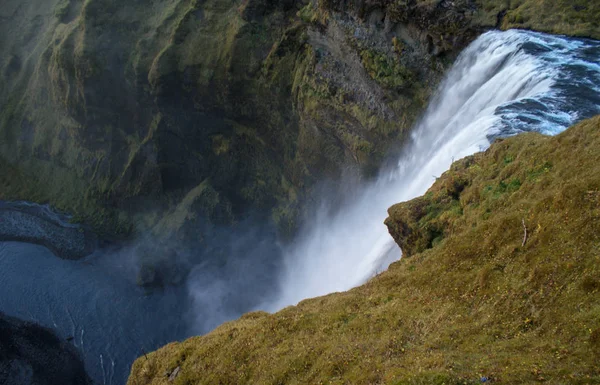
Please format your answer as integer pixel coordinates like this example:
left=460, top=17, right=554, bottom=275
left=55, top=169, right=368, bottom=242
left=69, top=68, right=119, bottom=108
left=0, top=313, right=92, bottom=385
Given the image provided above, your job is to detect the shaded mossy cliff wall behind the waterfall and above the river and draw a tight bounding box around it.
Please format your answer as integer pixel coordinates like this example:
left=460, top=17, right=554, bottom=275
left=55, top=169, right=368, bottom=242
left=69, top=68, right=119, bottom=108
left=0, top=0, right=598, bottom=244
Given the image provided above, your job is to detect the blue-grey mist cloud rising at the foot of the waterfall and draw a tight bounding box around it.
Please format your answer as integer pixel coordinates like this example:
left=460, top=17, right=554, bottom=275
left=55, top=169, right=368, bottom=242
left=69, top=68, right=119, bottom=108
left=186, top=219, right=283, bottom=334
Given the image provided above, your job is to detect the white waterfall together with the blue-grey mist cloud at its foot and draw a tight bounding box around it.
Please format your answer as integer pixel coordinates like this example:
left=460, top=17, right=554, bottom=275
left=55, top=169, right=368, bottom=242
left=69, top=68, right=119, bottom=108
left=177, top=31, right=600, bottom=333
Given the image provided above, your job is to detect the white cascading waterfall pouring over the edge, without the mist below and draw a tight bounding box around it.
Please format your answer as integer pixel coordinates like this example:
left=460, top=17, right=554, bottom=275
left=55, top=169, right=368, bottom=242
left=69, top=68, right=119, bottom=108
left=262, top=31, right=600, bottom=311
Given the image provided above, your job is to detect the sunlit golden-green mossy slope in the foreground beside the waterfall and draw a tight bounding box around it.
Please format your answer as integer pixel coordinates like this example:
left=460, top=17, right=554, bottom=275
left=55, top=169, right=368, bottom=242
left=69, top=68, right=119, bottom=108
left=129, top=117, right=600, bottom=385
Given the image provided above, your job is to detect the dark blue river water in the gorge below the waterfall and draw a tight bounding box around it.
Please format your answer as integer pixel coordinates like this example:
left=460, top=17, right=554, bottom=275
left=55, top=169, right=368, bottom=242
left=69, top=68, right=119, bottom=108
left=0, top=242, right=190, bottom=385
